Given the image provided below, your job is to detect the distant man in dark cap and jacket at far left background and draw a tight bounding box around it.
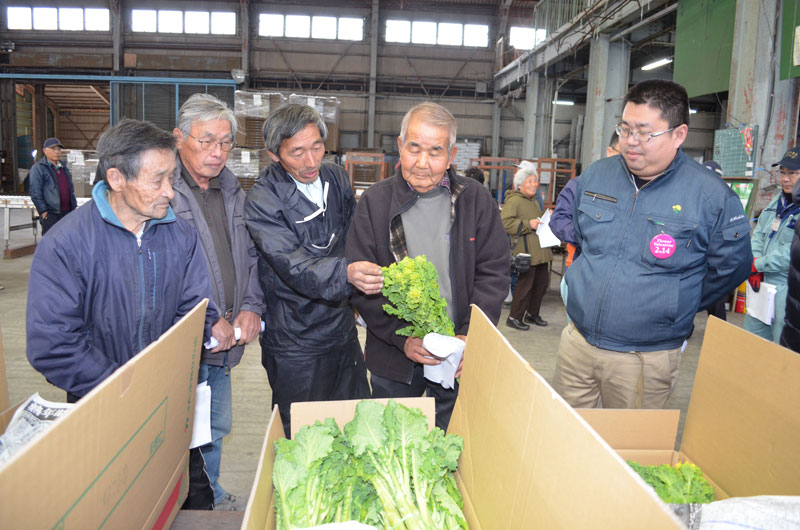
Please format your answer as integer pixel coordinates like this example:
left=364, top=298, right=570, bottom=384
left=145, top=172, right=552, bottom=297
left=28, top=138, right=78, bottom=235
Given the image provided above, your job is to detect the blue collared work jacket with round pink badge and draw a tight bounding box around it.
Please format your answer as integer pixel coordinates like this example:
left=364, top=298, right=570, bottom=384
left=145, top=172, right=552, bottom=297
left=566, top=150, right=753, bottom=351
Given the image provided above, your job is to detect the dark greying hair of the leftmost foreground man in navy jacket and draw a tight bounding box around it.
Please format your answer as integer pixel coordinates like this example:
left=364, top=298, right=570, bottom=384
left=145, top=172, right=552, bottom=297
left=95, top=120, right=176, bottom=184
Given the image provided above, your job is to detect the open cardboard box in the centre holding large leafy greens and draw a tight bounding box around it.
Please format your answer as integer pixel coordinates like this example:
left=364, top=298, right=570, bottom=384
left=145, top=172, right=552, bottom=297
left=242, top=307, right=683, bottom=530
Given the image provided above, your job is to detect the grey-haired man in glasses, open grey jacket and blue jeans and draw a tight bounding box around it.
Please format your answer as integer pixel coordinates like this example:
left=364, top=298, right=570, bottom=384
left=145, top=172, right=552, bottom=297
left=172, top=94, right=264, bottom=511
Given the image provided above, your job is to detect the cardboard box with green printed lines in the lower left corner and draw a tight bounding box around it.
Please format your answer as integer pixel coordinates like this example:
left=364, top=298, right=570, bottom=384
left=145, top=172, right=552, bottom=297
left=0, top=301, right=207, bottom=530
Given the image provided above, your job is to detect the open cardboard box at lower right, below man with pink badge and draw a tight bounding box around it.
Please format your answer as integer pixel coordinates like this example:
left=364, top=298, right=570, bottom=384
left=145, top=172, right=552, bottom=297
left=580, top=318, right=800, bottom=500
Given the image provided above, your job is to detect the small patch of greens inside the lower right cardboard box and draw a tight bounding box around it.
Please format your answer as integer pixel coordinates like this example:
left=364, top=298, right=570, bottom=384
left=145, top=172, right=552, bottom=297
left=628, top=462, right=714, bottom=504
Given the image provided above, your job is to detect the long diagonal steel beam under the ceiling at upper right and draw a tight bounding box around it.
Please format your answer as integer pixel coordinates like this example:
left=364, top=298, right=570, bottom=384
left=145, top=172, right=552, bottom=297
left=494, top=0, right=674, bottom=93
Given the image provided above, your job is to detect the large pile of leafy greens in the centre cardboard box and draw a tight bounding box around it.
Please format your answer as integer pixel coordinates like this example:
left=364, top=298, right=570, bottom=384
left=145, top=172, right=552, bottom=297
left=273, top=400, right=467, bottom=530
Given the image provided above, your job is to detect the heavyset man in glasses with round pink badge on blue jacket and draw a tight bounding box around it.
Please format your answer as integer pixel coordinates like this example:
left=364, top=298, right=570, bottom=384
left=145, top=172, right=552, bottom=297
left=553, top=80, right=753, bottom=408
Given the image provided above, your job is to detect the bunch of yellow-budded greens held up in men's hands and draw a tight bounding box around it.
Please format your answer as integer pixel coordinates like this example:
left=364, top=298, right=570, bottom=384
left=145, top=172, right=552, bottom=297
left=381, top=255, right=455, bottom=339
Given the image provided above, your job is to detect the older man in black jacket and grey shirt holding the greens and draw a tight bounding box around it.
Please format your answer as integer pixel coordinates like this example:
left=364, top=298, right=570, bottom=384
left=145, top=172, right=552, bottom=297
left=347, top=103, right=510, bottom=430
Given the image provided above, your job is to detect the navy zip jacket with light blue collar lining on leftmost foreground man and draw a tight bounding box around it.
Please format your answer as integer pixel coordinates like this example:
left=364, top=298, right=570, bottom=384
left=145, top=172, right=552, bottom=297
left=26, top=182, right=219, bottom=396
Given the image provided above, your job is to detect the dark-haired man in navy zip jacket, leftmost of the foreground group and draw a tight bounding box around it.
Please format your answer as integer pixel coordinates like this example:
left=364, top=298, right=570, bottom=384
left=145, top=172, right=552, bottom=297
left=26, top=120, right=219, bottom=402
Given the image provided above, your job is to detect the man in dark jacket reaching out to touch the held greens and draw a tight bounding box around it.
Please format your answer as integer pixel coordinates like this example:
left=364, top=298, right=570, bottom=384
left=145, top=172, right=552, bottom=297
left=244, top=105, right=383, bottom=436
